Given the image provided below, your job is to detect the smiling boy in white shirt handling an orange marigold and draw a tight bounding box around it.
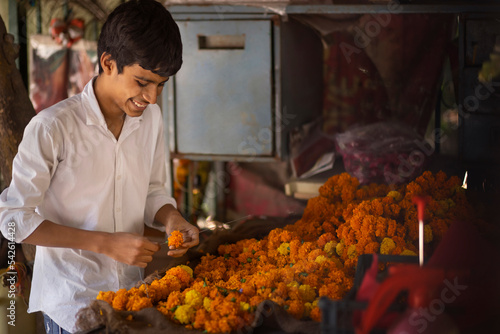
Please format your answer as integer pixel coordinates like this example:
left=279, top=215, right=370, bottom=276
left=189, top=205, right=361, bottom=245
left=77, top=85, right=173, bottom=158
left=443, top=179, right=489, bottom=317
left=0, top=0, right=198, bottom=333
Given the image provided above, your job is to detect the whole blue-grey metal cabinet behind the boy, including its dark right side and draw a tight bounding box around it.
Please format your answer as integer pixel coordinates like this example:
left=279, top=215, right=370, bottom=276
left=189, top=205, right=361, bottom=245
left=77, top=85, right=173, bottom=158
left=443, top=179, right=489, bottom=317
left=163, top=12, right=323, bottom=161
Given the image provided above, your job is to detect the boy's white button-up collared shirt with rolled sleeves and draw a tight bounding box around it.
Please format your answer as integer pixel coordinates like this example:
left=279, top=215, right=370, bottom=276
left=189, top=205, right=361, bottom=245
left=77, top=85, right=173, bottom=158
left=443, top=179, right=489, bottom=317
left=0, top=80, right=175, bottom=331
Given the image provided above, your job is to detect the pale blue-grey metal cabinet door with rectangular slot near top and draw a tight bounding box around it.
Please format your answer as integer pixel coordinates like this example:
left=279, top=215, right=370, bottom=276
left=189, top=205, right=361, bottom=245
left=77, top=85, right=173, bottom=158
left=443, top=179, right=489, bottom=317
left=173, top=20, right=274, bottom=156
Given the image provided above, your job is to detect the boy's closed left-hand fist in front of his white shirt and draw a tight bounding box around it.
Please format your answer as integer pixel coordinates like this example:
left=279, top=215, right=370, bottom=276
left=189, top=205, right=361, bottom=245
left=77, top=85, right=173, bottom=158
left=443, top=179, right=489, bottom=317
left=102, top=232, right=160, bottom=268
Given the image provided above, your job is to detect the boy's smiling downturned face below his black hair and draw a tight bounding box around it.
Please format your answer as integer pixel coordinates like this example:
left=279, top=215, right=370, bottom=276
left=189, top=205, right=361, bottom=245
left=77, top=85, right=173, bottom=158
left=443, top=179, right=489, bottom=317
left=109, top=64, right=168, bottom=117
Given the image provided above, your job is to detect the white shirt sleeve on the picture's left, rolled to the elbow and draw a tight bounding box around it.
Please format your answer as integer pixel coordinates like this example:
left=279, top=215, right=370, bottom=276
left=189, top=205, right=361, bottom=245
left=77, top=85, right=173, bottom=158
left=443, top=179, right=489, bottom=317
left=0, top=116, right=60, bottom=243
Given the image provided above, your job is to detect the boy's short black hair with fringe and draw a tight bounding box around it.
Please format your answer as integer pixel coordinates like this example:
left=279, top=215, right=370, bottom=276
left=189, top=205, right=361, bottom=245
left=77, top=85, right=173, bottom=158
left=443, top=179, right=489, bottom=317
left=97, top=0, right=182, bottom=77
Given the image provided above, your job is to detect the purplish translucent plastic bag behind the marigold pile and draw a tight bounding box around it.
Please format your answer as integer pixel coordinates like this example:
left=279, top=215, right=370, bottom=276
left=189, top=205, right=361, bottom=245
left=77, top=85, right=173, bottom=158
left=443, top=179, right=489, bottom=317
left=335, top=122, right=434, bottom=184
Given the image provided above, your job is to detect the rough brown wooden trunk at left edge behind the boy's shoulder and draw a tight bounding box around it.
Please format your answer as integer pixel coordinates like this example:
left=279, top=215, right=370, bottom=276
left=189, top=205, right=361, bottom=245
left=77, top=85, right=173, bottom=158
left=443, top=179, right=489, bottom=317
left=0, top=16, right=36, bottom=189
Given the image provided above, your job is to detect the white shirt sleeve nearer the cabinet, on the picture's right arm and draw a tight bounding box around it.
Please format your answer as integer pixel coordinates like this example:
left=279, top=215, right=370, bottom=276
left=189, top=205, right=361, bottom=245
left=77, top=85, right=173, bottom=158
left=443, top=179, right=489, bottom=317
left=144, top=108, right=177, bottom=231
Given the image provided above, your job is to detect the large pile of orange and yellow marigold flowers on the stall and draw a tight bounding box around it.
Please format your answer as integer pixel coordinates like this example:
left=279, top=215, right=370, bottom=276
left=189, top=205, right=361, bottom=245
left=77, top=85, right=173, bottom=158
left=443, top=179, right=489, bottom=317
left=97, top=172, right=480, bottom=333
